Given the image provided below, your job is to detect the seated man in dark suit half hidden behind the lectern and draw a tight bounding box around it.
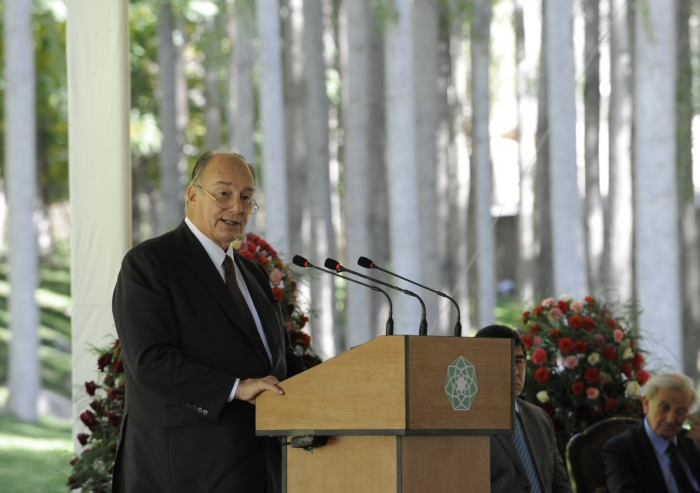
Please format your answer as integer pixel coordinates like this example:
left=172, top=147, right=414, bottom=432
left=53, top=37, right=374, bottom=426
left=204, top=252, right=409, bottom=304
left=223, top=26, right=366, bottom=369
left=475, top=325, right=571, bottom=493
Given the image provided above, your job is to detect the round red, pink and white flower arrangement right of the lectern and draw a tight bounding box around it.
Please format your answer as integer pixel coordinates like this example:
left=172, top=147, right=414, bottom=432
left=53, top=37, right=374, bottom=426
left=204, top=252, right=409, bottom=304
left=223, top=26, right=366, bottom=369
left=521, top=296, right=649, bottom=452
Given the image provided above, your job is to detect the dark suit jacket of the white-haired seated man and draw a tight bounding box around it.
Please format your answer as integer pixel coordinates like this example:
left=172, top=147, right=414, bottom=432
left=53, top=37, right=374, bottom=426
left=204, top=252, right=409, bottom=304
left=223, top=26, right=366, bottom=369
left=603, top=422, right=700, bottom=493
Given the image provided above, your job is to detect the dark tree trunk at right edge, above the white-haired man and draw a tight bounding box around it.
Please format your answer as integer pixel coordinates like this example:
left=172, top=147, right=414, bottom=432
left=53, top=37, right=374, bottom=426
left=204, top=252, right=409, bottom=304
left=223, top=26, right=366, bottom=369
left=676, top=0, right=700, bottom=381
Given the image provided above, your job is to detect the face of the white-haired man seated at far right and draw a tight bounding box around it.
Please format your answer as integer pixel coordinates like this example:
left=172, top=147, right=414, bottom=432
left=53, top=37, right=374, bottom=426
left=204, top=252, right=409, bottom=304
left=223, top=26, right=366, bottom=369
left=642, top=389, right=692, bottom=438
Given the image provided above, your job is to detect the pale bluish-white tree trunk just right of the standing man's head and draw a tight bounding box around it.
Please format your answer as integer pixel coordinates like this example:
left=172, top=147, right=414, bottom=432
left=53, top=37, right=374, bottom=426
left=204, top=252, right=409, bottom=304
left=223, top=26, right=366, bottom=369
left=255, top=0, right=290, bottom=255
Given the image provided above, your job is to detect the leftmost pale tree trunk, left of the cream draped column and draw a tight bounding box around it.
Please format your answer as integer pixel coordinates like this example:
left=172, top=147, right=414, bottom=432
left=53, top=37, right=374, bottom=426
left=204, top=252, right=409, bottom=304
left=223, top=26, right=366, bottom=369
left=4, top=0, right=41, bottom=421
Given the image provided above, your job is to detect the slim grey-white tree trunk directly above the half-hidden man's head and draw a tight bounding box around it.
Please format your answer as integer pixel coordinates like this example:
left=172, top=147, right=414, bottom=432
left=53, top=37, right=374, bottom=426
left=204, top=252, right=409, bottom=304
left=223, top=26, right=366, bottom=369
left=471, top=0, right=496, bottom=327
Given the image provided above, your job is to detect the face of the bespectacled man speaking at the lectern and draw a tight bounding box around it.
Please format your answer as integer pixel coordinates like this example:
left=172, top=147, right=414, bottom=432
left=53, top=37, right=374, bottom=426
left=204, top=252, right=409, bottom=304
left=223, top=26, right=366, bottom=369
left=187, top=155, right=255, bottom=250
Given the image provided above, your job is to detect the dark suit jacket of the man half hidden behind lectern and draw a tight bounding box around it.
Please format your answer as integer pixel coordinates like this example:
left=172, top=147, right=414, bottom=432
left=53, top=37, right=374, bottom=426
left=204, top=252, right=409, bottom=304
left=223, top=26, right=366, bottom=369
left=491, top=399, right=571, bottom=493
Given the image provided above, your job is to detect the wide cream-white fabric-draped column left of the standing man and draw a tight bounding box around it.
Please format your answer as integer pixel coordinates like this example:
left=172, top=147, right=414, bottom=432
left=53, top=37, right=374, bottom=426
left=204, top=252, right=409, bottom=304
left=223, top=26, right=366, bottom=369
left=67, top=0, right=131, bottom=446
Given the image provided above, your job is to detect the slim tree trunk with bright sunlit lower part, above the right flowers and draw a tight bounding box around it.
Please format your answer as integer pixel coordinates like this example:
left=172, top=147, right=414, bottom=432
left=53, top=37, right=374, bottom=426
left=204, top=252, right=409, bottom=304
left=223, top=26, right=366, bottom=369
left=583, top=0, right=604, bottom=293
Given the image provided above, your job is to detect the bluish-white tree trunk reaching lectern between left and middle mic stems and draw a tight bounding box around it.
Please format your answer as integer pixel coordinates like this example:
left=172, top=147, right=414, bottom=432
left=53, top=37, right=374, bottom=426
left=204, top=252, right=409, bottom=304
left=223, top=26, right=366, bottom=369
left=384, top=0, right=422, bottom=334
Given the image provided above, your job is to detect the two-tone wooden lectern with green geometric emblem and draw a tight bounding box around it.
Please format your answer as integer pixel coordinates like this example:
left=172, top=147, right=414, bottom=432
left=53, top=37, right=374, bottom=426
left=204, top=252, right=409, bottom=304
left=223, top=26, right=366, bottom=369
left=256, top=336, right=514, bottom=493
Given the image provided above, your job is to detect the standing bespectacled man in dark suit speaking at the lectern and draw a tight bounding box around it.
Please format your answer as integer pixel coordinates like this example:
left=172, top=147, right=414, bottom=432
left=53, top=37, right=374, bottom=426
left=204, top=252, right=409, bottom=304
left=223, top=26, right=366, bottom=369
left=112, top=152, right=304, bottom=493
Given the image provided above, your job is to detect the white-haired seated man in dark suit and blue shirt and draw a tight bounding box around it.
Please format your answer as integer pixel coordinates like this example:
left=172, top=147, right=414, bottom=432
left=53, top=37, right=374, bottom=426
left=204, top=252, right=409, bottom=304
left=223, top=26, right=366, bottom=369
left=603, top=373, right=700, bottom=493
